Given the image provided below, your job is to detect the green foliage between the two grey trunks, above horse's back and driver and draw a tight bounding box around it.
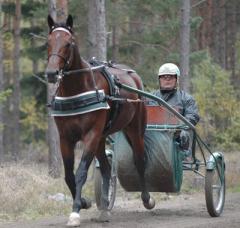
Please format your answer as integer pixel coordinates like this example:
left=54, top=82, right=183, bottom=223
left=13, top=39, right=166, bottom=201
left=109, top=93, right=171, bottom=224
left=106, top=0, right=182, bottom=88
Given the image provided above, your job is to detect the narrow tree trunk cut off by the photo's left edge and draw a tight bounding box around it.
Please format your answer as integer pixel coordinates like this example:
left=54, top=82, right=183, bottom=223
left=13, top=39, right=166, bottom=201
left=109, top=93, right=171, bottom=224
left=0, top=1, right=4, bottom=164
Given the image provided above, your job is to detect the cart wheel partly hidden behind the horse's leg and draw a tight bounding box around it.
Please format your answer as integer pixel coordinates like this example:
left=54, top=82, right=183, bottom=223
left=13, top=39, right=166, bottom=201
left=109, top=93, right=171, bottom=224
left=94, top=168, right=117, bottom=211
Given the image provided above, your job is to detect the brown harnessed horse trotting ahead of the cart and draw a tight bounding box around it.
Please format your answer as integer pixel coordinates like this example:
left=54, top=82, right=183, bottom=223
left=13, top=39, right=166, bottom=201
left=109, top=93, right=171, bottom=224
left=45, top=15, right=155, bottom=226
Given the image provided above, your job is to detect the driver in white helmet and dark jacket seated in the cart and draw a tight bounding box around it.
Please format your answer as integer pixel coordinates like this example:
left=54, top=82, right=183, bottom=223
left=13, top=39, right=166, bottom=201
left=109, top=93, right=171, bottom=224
left=148, top=63, right=199, bottom=157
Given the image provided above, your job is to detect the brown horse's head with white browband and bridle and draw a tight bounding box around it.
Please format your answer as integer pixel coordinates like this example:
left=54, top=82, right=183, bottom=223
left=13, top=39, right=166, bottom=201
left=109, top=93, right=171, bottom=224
left=45, top=15, right=75, bottom=83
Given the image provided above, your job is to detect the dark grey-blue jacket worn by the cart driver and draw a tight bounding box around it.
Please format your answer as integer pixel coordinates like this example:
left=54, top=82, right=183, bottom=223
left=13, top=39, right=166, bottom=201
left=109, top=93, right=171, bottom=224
left=148, top=90, right=200, bottom=125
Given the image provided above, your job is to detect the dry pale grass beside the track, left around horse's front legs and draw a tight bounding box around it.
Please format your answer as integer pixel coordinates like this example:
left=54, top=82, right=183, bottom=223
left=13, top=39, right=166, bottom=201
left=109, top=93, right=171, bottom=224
left=0, top=164, right=93, bottom=221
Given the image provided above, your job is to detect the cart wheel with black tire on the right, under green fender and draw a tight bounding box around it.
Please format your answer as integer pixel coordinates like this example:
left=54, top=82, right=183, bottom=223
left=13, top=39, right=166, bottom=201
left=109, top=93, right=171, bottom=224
left=205, top=158, right=226, bottom=217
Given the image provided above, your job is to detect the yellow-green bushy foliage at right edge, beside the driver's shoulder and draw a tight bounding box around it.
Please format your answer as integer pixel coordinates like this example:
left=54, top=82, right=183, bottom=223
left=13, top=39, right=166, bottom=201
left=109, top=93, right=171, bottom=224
left=193, top=56, right=240, bottom=150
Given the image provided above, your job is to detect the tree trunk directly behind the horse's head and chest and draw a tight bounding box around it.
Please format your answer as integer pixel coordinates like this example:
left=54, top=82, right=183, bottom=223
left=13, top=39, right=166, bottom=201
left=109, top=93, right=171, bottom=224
left=47, top=0, right=61, bottom=178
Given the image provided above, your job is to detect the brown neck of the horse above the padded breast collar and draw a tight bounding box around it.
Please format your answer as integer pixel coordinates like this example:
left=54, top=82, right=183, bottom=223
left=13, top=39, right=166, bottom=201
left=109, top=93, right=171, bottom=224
left=59, top=48, right=94, bottom=96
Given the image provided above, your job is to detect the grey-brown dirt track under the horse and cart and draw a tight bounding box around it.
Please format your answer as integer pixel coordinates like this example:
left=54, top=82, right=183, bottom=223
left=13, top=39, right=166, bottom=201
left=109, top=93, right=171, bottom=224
left=0, top=193, right=240, bottom=228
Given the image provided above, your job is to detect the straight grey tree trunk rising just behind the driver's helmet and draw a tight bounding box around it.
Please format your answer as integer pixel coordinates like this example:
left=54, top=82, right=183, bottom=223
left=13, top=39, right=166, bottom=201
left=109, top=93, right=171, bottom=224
left=180, top=0, right=190, bottom=91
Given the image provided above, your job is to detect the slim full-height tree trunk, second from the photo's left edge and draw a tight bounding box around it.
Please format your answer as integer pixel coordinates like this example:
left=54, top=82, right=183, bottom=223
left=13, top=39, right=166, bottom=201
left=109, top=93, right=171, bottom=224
left=12, top=0, right=21, bottom=160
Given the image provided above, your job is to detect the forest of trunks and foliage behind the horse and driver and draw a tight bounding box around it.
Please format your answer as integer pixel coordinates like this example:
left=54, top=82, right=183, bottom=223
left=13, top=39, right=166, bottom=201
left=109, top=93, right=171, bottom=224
left=0, top=0, right=240, bottom=176
